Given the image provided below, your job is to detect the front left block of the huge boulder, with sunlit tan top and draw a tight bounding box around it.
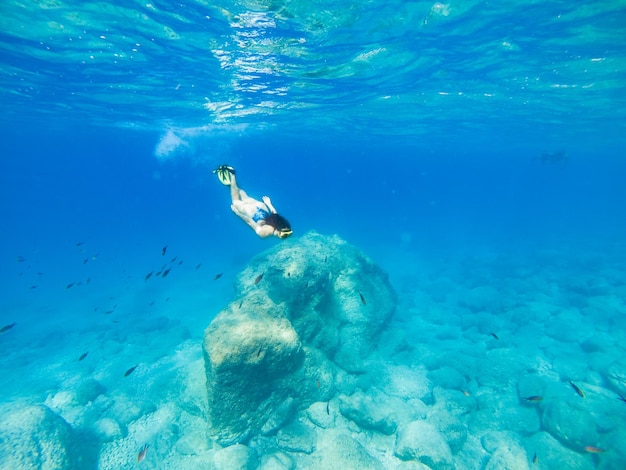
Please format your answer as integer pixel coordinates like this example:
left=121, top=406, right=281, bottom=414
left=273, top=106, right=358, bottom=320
left=204, top=300, right=303, bottom=445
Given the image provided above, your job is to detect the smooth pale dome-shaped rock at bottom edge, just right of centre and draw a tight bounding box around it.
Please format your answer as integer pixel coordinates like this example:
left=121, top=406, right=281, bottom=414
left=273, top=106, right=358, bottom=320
left=394, top=421, right=454, bottom=470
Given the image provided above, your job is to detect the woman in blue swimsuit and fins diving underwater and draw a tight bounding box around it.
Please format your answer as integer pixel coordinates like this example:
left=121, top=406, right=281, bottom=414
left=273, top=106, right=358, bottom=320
left=213, top=165, right=293, bottom=238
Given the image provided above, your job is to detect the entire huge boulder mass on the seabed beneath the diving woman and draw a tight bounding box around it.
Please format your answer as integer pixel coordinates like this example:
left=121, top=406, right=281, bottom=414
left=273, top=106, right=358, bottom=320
left=203, top=233, right=396, bottom=445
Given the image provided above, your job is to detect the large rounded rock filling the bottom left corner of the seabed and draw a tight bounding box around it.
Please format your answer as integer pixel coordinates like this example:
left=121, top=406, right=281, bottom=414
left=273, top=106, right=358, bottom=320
left=0, top=405, right=84, bottom=470
